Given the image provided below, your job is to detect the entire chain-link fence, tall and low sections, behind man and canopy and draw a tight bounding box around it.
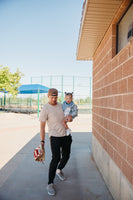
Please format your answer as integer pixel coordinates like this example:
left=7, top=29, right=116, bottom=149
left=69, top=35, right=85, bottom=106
left=0, top=75, right=92, bottom=113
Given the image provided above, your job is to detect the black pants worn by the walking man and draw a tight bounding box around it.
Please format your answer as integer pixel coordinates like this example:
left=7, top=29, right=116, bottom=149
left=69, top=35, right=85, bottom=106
left=48, top=135, right=72, bottom=184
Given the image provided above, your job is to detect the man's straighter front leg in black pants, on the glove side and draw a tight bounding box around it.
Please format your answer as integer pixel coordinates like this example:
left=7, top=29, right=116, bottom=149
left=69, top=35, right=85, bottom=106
left=48, top=137, right=60, bottom=184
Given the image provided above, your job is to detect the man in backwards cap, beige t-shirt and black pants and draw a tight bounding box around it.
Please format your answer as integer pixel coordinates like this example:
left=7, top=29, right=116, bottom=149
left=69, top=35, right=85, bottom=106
left=40, top=88, right=72, bottom=195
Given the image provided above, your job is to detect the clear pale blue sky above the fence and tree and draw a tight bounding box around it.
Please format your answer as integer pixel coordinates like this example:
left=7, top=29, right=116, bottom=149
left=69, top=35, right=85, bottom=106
left=0, top=0, right=92, bottom=84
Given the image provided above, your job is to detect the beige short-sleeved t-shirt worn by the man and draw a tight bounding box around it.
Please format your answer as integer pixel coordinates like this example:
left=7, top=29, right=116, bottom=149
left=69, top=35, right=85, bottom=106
left=39, top=103, right=66, bottom=137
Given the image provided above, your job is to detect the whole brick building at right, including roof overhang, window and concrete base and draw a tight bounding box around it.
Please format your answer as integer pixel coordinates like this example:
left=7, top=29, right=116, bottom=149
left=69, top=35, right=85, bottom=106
left=77, top=0, right=133, bottom=200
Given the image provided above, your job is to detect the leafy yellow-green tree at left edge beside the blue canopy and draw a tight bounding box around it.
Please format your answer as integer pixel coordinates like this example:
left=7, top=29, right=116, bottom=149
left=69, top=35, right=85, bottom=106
left=0, top=66, right=23, bottom=97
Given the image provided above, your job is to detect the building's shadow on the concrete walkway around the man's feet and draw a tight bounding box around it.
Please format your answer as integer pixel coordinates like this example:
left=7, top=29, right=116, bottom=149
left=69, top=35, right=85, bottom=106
left=0, top=132, right=113, bottom=200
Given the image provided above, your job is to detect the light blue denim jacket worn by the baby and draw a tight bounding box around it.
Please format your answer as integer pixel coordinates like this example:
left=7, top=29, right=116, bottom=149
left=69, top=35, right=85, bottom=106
left=62, top=101, right=78, bottom=119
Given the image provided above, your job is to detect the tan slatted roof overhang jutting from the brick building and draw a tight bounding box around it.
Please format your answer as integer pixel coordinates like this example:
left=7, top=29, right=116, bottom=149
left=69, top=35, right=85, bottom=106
left=77, top=0, right=123, bottom=60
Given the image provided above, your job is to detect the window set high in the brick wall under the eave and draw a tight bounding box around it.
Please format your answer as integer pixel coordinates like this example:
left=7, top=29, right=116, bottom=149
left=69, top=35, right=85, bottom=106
left=117, top=3, right=133, bottom=53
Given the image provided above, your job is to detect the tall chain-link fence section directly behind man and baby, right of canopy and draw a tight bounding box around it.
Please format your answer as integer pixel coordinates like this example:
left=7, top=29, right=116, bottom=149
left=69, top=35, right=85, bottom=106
left=31, top=75, right=92, bottom=113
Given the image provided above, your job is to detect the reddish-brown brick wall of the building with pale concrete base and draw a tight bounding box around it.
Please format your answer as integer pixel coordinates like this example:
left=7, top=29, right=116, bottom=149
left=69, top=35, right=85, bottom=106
left=93, top=1, right=133, bottom=199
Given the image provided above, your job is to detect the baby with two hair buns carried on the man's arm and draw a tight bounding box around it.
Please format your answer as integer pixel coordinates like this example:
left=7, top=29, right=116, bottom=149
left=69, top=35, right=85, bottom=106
left=62, top=92, right=78, bottom=135
